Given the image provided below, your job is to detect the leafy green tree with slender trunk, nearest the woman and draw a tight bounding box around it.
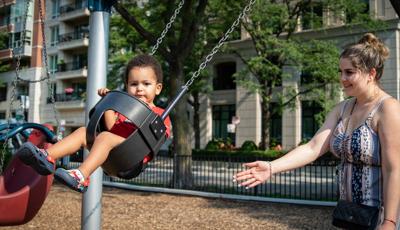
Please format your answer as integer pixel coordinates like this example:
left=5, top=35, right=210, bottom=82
left=231, top=0, right=378, bottom=149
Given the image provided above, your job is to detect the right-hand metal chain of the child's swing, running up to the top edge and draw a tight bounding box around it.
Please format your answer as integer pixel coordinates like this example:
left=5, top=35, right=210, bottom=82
left=183, top=0, right=256, bottom=89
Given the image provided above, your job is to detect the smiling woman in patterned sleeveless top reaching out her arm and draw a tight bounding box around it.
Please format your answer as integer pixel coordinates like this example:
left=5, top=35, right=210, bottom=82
left=234, top=33, right=400, bottom=229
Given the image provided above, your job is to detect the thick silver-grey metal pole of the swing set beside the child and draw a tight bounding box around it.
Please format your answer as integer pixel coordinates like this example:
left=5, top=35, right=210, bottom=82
left=81, top=0, right=115, bottom=230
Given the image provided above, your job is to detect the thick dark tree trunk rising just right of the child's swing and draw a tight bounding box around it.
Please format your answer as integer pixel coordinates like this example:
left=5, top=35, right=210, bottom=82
left=170, top=62, right=193, bottom=189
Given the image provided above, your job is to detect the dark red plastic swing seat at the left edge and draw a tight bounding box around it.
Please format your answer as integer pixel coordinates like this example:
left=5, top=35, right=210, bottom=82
left=0, top=123, right=54, bottom=226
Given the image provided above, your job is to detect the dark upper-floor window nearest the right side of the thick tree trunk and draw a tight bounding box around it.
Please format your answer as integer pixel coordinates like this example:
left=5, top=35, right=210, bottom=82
left=213, top=62, right=236, bottom=90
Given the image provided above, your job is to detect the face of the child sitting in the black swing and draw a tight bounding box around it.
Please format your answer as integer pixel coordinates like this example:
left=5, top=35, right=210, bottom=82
left=126, top=67, right=162, bottom=106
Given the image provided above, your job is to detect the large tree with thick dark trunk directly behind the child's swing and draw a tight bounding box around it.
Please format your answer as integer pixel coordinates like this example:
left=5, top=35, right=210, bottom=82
left=111, top=0, right=242, bottom=188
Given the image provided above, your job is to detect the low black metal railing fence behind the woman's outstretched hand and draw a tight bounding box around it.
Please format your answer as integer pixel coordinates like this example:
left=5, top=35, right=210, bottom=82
left=66, top=156, right=339, bottom=201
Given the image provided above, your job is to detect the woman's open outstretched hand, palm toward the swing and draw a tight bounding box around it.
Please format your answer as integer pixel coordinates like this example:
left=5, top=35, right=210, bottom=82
left=233, top=161, right=272, bottom=189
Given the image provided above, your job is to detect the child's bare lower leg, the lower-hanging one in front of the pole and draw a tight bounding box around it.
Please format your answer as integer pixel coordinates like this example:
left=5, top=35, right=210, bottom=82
left=79, top=132, right=125, bottom=178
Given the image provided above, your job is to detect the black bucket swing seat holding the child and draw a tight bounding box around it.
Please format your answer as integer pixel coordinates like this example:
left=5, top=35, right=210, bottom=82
left=86, top=91, right=166, bottom=179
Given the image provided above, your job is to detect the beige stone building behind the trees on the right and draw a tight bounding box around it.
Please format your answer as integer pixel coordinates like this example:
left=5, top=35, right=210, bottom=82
left=200, top=0, right=400, bottom=149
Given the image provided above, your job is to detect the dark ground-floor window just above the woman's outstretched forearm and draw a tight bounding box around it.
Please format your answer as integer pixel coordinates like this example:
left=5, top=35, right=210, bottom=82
left=301, top=101, right=322, bottom=141
